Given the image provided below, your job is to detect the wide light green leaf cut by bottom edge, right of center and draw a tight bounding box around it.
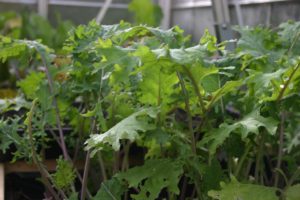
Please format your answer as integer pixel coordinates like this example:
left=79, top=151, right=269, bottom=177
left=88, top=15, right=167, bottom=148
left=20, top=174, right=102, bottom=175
left=208, top=177, right=279, bottom=200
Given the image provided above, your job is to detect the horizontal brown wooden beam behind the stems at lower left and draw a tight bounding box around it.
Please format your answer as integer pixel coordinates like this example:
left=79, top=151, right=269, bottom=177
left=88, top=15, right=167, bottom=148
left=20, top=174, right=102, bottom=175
left=4, top=160, right=84, bottom=174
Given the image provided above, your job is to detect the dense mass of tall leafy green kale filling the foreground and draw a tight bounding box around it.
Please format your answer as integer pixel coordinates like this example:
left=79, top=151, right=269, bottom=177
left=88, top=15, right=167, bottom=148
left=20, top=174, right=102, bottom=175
left=0, top=21, right=300, bottom=200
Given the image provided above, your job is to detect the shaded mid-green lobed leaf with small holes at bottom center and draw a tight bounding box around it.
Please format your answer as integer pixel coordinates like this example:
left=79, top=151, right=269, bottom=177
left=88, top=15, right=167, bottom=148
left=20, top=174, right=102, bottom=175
left=117, top=159, right=183, bottom=200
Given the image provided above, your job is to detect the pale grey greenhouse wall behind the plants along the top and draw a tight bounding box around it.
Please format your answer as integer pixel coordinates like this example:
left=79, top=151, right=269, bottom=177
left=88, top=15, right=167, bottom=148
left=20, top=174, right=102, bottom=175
left=0, top=0, right=300, bottom=41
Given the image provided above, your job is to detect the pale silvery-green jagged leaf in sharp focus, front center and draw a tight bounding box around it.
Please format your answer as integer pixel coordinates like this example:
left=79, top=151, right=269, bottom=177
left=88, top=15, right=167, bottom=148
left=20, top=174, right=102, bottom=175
left=85, top=108, right=157, bottom=154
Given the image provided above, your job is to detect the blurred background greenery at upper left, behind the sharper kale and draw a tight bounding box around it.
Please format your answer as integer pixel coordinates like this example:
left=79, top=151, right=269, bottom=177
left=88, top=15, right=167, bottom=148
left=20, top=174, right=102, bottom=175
left=0, top=12, right=73, bottom=91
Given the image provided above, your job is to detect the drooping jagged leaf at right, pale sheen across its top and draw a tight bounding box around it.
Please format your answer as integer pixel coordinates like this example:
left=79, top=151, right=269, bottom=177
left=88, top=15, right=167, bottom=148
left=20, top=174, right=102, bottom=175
left=198, top=111, right=278, bottom=155
